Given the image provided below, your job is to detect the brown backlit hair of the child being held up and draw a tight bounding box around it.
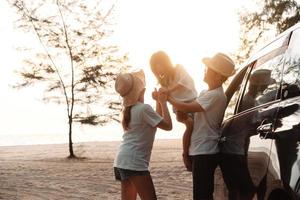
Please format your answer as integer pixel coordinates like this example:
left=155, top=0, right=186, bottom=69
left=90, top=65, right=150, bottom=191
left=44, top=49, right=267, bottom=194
left=150, top=51, right=175, bottom=87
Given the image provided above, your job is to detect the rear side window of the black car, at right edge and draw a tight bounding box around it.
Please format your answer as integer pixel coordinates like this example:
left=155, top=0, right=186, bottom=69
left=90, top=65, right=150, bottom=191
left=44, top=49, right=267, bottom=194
left=282, top=29, right=300, bottom=99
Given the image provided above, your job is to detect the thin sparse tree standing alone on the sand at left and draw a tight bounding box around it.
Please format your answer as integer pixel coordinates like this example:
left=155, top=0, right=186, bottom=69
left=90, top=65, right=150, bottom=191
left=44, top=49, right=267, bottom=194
left=9, top=0, right=127, bottom=158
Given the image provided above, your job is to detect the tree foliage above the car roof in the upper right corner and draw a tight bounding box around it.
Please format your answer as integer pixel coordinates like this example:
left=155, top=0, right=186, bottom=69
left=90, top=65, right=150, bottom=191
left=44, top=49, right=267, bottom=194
left=236, top=0, right=300, bottom=63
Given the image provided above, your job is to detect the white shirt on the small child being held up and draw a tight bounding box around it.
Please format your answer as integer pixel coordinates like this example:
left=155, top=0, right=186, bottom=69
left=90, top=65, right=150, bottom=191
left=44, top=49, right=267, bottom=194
left=167, top=65, right=197, bottom=102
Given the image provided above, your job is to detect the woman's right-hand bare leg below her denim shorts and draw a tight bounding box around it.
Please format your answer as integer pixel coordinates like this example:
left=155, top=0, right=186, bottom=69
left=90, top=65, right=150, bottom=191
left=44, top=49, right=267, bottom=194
left=130, top=174, right=157, bottom=200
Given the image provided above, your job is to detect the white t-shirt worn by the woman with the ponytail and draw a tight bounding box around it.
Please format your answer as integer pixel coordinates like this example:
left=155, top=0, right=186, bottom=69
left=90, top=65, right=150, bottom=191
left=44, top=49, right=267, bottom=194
left=114, top=103, right=162, bottom=171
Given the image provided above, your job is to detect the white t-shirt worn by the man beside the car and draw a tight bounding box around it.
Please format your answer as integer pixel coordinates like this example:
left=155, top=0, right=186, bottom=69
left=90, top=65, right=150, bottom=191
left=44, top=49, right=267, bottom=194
left=189, top=87, right=227, bottom=155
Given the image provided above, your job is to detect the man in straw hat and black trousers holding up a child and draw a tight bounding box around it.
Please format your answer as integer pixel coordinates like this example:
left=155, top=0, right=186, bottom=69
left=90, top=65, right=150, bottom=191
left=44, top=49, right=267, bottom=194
left=168, top=53, right=234, bottom=200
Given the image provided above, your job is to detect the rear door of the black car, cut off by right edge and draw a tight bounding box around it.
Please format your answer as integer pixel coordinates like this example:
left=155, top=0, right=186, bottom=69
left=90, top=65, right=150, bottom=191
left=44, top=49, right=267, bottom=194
left=270, top=29, right=300, bottom=199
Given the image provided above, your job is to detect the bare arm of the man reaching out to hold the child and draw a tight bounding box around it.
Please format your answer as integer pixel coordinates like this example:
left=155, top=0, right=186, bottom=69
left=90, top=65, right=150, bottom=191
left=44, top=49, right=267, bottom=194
left=168, top=96, right=204, bottom=112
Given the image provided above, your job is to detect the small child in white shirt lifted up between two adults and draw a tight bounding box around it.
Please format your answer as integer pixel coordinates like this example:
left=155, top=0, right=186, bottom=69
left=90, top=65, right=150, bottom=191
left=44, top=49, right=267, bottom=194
left=150, top=51, right=197, bottom=171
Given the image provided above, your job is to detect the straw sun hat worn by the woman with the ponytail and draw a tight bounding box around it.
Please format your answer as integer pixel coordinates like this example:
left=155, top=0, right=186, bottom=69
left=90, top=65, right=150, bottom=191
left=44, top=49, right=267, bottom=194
left=115, top=70, right=146, bottom=107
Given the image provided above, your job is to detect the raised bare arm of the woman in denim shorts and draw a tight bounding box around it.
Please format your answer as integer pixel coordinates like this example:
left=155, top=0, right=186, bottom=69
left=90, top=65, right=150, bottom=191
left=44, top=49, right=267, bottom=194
left=157, top=93, right=172, bottom=130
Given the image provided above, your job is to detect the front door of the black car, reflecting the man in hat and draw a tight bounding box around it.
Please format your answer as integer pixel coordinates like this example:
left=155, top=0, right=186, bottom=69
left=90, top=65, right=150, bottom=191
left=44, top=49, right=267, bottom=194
left=222, top=32, right=289, bottom=198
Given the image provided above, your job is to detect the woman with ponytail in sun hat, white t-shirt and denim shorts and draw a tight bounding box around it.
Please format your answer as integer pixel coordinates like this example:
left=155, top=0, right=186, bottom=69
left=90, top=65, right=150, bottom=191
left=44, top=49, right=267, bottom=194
left=114, top=71, right=172, bottom=200
